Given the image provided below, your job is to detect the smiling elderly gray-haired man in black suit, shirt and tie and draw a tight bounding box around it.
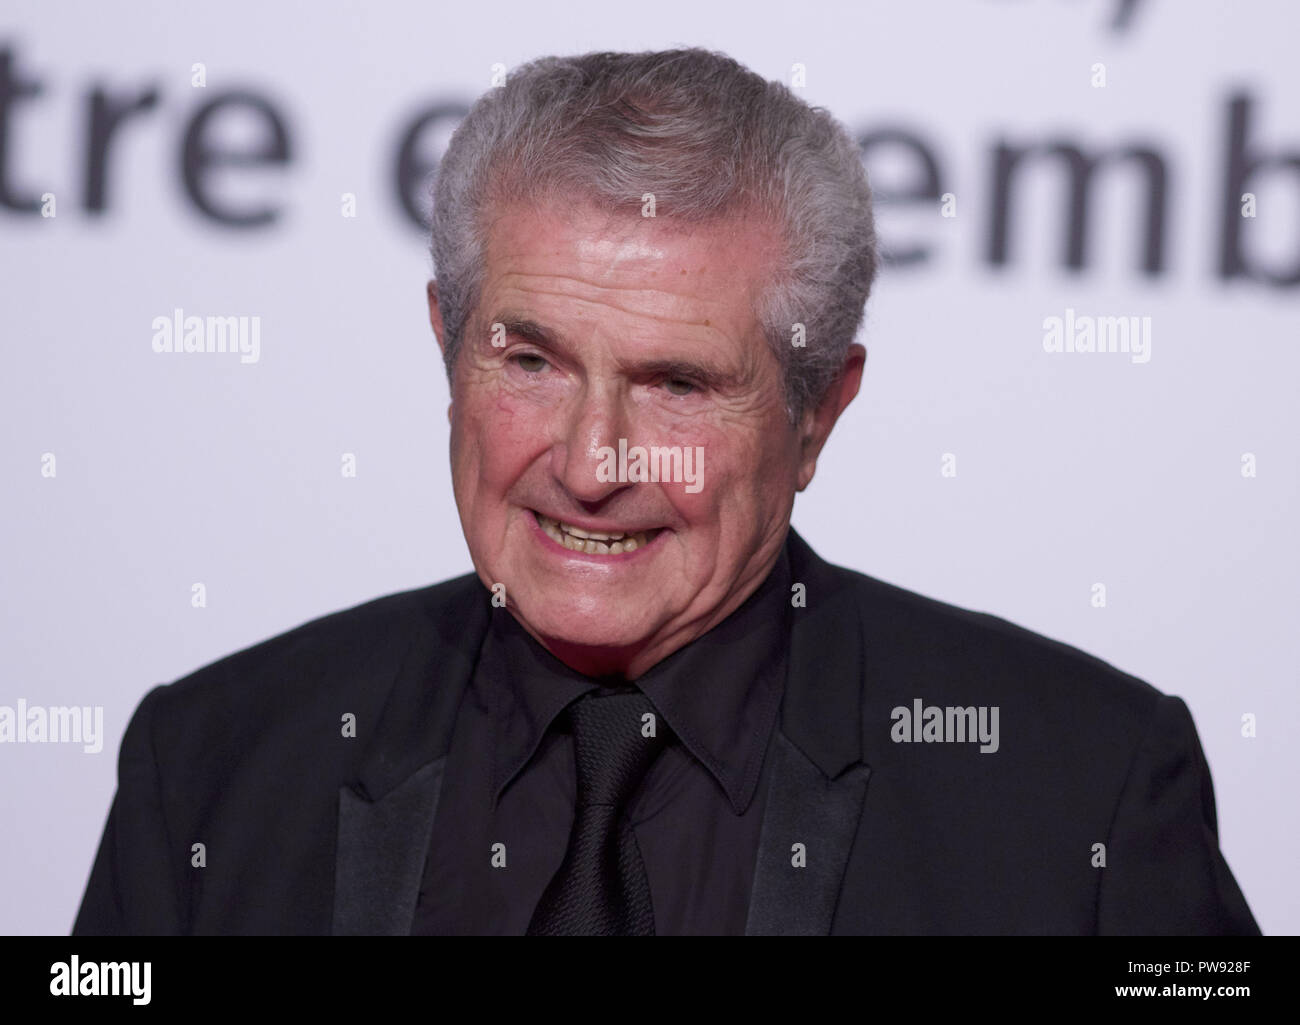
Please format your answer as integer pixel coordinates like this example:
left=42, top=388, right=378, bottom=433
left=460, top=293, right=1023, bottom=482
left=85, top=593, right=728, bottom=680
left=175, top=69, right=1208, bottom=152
left=75, top=51, right=1257, bottom=935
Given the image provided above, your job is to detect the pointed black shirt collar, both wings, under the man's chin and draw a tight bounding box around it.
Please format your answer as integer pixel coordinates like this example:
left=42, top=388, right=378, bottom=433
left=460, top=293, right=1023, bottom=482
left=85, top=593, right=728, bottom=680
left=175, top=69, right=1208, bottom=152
left=478, top=542, right=790, bottom=814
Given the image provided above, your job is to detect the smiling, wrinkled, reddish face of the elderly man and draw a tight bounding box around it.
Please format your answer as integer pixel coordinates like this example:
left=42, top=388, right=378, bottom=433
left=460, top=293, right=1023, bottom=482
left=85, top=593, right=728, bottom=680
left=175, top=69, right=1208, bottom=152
left=430, top=206, right=819, bottom=679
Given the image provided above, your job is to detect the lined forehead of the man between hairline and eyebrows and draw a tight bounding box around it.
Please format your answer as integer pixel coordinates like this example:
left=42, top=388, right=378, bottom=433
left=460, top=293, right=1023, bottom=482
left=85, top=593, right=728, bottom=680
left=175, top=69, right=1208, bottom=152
left=482, top=202, right=780, bottom=329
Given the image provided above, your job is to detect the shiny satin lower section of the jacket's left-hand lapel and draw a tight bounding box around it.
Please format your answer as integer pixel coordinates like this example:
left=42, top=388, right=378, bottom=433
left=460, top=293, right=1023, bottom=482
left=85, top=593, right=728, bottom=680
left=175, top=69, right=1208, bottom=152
left=333, top=756, right=447, bottom=937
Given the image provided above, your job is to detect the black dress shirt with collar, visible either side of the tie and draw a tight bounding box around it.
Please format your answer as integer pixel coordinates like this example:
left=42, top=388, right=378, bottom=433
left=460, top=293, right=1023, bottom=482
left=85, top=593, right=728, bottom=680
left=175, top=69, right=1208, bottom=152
left=411, top=548, right=790, bottom=935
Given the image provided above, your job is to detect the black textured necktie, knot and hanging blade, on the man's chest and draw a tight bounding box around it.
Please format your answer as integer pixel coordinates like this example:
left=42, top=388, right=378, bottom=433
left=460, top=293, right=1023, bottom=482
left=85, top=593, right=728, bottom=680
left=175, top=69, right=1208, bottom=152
left=528, top=688, right=667, bottom=937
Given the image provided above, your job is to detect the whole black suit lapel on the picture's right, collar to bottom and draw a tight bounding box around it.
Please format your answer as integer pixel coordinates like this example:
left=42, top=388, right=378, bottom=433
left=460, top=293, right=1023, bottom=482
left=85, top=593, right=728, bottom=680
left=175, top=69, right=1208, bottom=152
left=745, top=529, right=871, bottom=935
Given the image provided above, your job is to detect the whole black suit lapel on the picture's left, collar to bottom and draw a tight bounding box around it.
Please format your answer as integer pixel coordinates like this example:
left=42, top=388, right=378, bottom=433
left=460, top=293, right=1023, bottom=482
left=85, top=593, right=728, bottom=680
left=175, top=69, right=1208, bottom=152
left=333, top=575, right=488, bottom=935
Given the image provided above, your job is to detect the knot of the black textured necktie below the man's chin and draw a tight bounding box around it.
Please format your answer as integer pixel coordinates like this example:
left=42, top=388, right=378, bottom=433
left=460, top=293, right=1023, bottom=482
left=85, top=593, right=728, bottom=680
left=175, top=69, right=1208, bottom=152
left=569, top=689, right=666, bottom=806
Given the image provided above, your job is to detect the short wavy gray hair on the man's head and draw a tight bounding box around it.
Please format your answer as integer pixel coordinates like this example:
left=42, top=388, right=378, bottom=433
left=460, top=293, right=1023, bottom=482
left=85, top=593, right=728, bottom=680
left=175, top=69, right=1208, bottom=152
left=432, top=49, right=879, bottom=423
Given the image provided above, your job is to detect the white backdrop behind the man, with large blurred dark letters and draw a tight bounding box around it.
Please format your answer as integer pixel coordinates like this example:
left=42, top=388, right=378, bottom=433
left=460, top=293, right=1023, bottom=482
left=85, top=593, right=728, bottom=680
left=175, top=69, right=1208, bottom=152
left=0, top=0, right=1300, bottom=933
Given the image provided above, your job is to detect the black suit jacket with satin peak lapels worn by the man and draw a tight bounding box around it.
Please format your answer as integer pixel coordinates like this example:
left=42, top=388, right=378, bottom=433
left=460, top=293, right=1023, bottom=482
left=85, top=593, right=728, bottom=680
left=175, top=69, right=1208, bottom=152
left=74, top=531, right=1258, bottom=934
